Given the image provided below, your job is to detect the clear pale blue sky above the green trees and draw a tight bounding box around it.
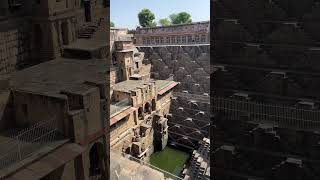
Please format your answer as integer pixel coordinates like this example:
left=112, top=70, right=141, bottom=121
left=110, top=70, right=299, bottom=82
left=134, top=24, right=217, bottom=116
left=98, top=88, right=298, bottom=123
left=110, top=0, right=210, bottom=29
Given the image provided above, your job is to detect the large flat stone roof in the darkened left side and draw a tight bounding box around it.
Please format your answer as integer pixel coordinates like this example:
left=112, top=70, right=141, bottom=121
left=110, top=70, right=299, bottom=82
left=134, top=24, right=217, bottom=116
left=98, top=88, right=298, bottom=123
left=10, top=58, right=108, bottom=96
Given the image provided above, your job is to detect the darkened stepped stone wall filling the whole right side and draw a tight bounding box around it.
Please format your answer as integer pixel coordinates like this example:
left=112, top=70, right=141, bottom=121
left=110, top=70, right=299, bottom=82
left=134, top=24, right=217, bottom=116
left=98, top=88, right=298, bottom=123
left=212, top=0, right=320, bottom=180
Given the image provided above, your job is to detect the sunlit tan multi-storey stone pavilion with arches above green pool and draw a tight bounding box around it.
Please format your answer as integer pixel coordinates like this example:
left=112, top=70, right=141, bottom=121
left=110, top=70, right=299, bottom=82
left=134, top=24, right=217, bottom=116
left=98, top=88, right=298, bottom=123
left=110, top=37, right=178, bottom=160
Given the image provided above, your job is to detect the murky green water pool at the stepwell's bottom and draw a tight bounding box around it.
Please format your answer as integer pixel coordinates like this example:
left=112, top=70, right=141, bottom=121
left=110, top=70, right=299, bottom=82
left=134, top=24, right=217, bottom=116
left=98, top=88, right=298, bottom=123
left=150, top=147, right=190, bottom=176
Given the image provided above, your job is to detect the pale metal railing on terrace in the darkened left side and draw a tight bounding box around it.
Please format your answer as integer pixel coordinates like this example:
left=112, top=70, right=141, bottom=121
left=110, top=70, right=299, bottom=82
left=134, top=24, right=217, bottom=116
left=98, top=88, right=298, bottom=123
left=0, top=120, right=60, bottom=169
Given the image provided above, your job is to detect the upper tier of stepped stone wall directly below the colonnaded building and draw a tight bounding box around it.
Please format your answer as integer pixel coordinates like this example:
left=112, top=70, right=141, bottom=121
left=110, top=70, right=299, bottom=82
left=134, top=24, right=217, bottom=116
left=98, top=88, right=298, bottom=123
left=138, top=45, right=210, bottom=95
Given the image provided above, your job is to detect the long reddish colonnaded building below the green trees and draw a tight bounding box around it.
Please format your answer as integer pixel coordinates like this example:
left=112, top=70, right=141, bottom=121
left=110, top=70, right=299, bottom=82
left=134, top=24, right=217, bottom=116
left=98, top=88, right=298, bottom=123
left=134, top=21, right=210, bottom=45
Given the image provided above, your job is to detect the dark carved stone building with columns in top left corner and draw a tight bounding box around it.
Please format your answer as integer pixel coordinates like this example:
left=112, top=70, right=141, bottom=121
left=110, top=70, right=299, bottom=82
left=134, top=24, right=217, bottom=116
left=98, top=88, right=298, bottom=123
left=0, top=0, right=109, bottom=75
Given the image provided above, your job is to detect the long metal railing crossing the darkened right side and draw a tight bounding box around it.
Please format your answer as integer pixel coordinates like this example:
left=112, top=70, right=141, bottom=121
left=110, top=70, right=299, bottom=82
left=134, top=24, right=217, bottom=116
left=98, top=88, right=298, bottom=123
left=212, top=97, right=320, bottom=129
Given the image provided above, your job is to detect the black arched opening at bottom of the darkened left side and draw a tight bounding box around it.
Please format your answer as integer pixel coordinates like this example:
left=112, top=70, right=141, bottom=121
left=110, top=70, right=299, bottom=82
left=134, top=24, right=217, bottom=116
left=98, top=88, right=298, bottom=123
left=89, top=142, right=104, bottom=176
